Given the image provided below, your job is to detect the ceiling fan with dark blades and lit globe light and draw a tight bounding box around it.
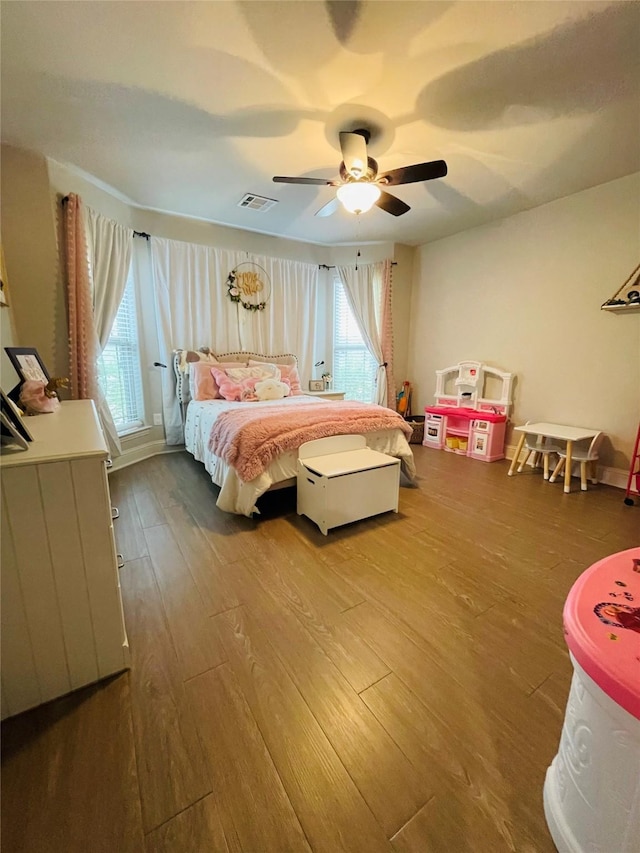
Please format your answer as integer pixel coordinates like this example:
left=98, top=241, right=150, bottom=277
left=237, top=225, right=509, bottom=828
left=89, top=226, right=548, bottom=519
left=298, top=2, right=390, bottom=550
left=273, top=129, right=447, bottom=216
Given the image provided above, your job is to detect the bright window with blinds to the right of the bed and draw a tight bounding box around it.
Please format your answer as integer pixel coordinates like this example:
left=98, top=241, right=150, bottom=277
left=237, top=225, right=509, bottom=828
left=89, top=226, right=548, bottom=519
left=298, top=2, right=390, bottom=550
left=333, top=279, right=378, bottom=403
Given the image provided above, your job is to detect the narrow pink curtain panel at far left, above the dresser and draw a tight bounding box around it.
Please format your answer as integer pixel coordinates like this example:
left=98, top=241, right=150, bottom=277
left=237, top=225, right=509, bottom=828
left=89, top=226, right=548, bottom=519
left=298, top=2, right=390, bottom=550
left=65, top=193, right=98, bottom=400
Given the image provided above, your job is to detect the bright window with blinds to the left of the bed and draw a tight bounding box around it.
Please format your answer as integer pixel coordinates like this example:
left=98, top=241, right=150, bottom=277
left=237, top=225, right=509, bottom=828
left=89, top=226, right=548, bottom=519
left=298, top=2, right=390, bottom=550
left=98, top=267, right=144, bottom=435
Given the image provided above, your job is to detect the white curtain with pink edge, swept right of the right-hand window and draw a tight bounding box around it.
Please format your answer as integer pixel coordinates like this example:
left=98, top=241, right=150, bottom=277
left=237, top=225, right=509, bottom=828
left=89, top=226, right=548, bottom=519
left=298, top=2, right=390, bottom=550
left=336, top=261, right=395, bottom=408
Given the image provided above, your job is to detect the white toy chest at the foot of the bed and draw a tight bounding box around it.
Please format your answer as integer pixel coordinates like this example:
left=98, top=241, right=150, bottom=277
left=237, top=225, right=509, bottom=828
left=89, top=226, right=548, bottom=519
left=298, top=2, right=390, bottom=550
left=297, top=435, right=400, bottom=536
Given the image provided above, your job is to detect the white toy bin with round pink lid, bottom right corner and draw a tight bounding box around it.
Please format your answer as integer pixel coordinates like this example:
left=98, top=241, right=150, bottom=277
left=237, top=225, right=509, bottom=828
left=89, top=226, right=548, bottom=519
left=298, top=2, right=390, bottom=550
left=544, top=547, right=640, bottom=853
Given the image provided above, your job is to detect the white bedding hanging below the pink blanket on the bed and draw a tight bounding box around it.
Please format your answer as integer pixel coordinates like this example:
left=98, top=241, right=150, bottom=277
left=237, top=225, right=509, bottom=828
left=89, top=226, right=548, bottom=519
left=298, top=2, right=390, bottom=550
left=184, top=395, right=416, bottom=517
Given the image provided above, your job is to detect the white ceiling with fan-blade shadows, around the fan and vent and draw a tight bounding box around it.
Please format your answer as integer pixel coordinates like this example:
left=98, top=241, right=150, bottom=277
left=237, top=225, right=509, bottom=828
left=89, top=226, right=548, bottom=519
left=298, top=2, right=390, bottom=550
left=1, top=0, right=640, bottom=245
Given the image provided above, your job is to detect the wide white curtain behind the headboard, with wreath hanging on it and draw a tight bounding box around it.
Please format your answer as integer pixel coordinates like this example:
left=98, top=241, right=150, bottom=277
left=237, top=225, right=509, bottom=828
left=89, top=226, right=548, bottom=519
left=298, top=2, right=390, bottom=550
left=150, top=237, right=319, bottom=444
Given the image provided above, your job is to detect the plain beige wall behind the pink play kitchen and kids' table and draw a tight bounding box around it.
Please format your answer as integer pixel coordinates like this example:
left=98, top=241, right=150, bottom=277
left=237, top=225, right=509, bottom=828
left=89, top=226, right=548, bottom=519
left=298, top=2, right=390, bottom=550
left=409, top=174, right=640, bottom=469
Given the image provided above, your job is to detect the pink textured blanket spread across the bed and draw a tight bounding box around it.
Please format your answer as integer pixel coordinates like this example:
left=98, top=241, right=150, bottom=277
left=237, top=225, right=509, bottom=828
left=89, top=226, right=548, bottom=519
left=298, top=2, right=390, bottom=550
left=209, top=401, right=413, bottom=482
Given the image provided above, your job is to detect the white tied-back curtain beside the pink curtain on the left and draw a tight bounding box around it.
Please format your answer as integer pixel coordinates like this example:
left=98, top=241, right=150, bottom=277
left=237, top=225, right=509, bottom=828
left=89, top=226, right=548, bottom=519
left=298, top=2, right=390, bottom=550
left=86, top=208, right=133, bottom=455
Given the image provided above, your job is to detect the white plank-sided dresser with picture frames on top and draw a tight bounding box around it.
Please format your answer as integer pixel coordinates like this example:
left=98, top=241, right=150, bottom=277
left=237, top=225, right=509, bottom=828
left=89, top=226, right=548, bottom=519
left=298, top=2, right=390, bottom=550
left=0, top=400, right=129, bottom=719
